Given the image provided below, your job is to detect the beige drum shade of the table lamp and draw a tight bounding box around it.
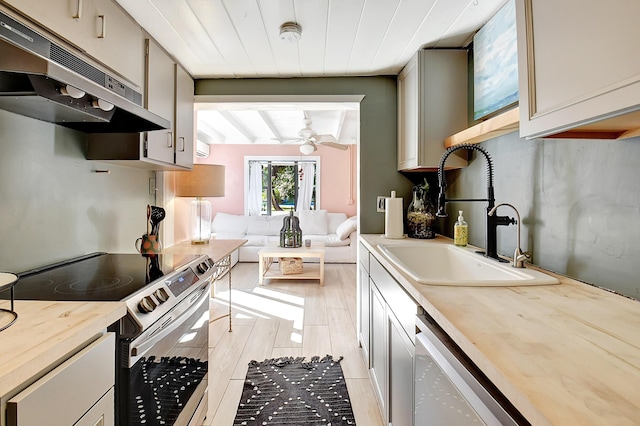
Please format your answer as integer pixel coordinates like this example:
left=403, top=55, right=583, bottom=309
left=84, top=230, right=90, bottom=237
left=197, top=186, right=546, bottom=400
left=175, top=164, right=224, bottom=197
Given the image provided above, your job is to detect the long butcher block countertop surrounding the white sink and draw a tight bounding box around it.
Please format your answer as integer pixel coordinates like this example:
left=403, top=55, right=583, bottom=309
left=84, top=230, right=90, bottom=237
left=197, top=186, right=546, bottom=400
left=360, top=235, right=640, bottom=426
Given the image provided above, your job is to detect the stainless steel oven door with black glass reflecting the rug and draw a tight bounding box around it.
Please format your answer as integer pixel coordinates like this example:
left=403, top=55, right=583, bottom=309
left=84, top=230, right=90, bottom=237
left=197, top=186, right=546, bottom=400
left=118, top=282, right=210, bottom=425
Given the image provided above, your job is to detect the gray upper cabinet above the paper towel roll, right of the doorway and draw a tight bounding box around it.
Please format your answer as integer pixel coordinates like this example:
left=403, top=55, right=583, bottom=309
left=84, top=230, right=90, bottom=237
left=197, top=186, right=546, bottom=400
left=398, top=49, right=468, bottom=171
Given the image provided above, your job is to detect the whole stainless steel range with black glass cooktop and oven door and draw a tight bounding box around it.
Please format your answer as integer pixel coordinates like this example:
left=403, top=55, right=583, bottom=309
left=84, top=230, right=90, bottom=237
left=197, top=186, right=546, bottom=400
left=7, top=253, right=219, bottom=426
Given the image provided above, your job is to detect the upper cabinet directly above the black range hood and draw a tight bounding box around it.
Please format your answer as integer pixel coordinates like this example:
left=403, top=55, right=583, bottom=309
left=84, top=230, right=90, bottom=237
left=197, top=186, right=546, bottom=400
left=4, top=0, right=144, bottom=88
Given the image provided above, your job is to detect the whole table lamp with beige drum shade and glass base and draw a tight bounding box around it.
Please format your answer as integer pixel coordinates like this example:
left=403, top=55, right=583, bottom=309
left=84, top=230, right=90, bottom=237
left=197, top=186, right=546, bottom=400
left=175, top=164, right=224, bottom=244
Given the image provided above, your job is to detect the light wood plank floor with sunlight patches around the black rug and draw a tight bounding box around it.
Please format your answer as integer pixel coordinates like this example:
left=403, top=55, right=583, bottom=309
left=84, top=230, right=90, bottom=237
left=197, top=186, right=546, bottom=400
left=204, top=263, right=382, bottom=426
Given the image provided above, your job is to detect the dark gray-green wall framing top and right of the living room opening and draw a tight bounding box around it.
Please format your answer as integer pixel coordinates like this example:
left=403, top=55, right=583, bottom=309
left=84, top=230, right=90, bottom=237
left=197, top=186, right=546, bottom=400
left=196, top=76, right=411, bottom=233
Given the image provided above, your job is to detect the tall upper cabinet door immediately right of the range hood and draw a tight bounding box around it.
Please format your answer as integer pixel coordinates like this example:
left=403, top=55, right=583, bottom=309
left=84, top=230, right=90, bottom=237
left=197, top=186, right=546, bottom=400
left=145, top=39, right=175, bottom=164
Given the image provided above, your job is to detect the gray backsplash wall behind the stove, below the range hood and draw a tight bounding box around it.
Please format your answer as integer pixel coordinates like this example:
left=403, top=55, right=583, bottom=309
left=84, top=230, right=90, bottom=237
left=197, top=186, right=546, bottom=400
left=0, top=110, right=155, bottom=272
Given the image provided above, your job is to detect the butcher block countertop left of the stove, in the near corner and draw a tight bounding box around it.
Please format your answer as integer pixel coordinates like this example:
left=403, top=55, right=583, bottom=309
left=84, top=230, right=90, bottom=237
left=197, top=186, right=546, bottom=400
left=0, top=300, right=127, bottom=397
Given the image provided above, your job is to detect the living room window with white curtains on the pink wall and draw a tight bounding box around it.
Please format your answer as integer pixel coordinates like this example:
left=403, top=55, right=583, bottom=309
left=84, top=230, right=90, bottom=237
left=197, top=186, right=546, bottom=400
left=245, top=157, right=320, bottom=216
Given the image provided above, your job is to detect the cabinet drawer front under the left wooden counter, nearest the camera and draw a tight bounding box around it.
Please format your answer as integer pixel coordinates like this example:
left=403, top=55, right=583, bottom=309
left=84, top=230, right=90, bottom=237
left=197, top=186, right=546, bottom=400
left=7, top=333, right=115, bottom=426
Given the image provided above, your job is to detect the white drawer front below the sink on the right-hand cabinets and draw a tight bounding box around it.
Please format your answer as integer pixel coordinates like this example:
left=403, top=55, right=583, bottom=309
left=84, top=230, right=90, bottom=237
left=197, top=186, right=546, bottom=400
left=369, top=256, right=418, bottom=343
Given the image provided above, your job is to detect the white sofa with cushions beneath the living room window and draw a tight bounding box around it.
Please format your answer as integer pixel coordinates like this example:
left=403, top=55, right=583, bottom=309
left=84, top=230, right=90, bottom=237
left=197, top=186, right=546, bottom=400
left=212, top=210, right=358, bottom=263
